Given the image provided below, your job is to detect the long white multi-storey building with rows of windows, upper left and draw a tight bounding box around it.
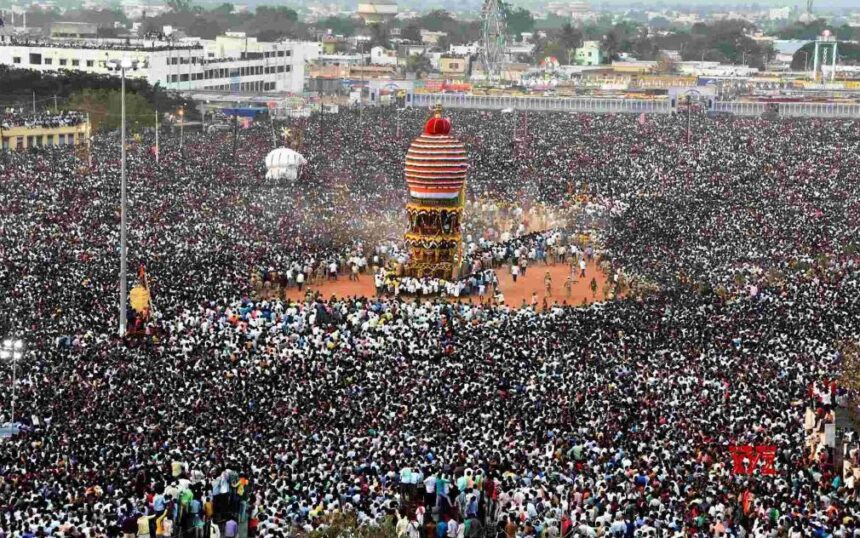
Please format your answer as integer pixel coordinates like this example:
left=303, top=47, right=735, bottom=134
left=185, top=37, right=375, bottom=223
left=0, top=33, right=317, bottom=93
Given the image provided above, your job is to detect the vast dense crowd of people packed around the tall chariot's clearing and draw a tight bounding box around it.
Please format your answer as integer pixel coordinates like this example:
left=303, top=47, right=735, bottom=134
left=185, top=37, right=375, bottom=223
left=0, top=110, right=860, bottom=538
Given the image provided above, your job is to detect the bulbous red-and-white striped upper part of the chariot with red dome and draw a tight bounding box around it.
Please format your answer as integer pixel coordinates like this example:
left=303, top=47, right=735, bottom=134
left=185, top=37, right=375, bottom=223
left=406, top=108, right=469, bottom=200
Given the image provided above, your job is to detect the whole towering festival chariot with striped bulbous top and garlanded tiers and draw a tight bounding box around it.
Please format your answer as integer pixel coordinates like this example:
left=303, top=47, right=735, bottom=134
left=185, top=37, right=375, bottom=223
left=405, top=106, right=468, bottom=279
